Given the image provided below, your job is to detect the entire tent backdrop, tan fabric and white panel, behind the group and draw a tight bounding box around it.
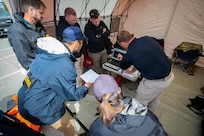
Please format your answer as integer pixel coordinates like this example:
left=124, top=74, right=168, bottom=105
left=7, top=0, right=204, bottom=68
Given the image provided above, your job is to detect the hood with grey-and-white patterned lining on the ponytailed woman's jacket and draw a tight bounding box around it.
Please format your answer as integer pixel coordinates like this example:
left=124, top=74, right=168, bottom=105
left=108, top=97, right=148, bottom=134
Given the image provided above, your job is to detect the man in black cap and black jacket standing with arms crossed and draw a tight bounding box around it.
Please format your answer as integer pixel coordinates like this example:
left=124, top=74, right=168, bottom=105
left=84, top=9, right=110, bottom=74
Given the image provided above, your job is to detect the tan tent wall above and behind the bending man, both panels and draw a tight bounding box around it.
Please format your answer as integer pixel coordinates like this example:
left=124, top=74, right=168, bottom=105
left=119, top=0, right=204, bottom=68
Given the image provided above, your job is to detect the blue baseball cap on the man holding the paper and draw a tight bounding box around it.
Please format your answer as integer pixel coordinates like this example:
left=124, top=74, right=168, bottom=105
left=62, top=26, right=88, bottom=41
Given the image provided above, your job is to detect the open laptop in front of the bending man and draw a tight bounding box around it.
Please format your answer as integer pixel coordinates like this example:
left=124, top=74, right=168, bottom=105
left=104, top=48, right=126, bottom=70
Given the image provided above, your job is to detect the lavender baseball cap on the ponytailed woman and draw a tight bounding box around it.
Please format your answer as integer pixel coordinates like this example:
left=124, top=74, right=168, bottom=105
left=93, top=74, right=120, bottom=101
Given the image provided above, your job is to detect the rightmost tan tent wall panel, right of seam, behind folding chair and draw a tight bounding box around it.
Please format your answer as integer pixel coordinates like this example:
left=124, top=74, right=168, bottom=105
left=165, top=0, right=204, bottom=68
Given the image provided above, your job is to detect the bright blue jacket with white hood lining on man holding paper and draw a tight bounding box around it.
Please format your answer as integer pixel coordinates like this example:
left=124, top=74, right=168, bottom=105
left=18, top=37, right=88, bottom=125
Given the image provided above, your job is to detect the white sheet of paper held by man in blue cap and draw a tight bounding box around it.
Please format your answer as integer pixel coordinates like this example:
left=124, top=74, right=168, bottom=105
left=80, top=69, right=99, bottom=83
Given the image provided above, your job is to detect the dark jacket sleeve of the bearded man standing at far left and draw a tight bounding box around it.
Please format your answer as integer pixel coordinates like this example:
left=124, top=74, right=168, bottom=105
left=8, top=26, right=36, bottom=70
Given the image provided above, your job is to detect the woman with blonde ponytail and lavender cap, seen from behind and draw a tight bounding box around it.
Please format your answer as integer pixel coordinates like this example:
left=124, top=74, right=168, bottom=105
left=88, top=74, right=167, bottom=136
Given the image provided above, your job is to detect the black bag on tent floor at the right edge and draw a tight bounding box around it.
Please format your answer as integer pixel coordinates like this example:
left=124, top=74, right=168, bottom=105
left=187, top=95, right=204, bottom=115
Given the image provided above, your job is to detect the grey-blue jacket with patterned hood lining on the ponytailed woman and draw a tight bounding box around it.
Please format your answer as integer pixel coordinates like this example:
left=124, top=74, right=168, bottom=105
left=89, top=97, right=166, bottom=136
